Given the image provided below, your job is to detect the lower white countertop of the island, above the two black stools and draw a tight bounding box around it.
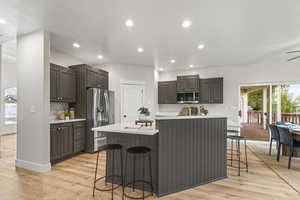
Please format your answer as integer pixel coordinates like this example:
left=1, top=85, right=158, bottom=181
left=92, top=123, right=158, bottom=135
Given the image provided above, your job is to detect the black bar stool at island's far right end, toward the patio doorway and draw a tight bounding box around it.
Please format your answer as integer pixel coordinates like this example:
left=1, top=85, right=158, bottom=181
left=227, top=135, right=248, bottom=176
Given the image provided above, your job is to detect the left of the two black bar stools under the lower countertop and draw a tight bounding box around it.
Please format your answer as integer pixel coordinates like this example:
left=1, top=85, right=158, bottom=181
left=93, top=144, right=123, bottom=199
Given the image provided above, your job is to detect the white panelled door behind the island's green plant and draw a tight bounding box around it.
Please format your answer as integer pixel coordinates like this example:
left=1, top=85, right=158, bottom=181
left=121, top=84, right=145, bottom=122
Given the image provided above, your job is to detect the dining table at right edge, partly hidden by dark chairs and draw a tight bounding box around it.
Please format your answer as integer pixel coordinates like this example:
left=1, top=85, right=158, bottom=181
left=276, top=123, right=300, bottom=157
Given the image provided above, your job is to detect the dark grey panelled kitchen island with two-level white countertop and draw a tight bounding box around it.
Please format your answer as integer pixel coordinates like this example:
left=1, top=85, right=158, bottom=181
left=93, top=116, right=227, bottom=196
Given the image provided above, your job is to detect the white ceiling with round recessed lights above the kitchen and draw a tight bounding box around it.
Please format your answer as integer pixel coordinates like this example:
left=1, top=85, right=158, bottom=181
left=0, top=0, right=300, bottom=70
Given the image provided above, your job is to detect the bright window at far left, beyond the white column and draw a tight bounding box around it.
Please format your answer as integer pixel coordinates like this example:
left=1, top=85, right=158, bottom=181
left=4, top=88, right=17, bottom=125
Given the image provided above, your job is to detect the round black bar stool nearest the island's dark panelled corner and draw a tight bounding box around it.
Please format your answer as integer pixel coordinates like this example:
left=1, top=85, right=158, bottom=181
left=123, top=146, right=153, bottom=199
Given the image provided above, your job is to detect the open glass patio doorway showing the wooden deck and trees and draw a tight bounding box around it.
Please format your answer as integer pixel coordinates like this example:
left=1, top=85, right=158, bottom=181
left=240, top=83, right=300, bottom=141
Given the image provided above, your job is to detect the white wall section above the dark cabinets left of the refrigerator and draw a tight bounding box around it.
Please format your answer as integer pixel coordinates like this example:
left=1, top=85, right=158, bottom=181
left=50, top=49, right=84, bottom=67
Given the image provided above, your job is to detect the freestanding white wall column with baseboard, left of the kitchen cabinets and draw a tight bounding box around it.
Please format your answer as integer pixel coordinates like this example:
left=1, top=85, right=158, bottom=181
left=16, top=31, right=51, bottom=172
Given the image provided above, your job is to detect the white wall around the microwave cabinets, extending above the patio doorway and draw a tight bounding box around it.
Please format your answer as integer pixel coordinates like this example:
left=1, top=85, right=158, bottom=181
left=159, top=57, right=300, bottom=123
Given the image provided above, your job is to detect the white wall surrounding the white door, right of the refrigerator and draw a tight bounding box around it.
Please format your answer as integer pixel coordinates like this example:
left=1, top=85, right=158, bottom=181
left=99, top=64, right=157, bottom=123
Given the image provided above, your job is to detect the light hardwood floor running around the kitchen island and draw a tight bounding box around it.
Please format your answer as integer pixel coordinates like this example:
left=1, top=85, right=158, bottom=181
left=0, top=135, right=300, bottom=200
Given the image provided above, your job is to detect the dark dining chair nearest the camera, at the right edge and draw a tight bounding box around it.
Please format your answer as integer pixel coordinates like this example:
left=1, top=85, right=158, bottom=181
left=277, top=126, right=300, bottom=169
